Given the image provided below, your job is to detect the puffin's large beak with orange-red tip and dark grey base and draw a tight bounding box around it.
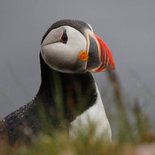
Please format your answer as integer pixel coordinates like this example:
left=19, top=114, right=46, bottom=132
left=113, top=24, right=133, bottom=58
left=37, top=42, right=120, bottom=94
left=87, top=33, right=115, bottom=72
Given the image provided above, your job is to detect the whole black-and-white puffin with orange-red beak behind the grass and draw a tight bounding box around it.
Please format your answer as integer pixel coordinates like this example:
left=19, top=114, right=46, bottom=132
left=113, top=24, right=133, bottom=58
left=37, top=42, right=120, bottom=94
left=0, top=19, right=115, bottom=145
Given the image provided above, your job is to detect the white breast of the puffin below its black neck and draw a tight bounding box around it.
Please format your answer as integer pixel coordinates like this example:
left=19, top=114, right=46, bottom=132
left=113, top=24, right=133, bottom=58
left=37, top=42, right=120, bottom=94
left=69, top=85, right=111, bottom=141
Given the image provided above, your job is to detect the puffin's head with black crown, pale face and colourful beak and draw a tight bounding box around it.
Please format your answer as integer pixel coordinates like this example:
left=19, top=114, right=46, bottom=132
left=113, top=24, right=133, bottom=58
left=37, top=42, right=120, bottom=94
left=41, top=20, right=115, bottom=73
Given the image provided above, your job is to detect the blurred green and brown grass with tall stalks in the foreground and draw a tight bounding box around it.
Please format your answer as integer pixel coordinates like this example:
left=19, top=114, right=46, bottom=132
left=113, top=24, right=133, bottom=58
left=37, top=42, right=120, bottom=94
left=0, top=72, right=155, bottom=155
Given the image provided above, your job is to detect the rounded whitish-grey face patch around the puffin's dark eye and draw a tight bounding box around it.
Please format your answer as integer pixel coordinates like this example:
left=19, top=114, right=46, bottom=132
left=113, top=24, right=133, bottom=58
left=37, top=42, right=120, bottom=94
left=41, top=26, right=87, bottom=73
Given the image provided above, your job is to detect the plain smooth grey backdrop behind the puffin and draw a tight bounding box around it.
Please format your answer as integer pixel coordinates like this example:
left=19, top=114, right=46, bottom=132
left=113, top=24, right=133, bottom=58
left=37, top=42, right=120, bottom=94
left=0, top=0, right=155, bottom=123
